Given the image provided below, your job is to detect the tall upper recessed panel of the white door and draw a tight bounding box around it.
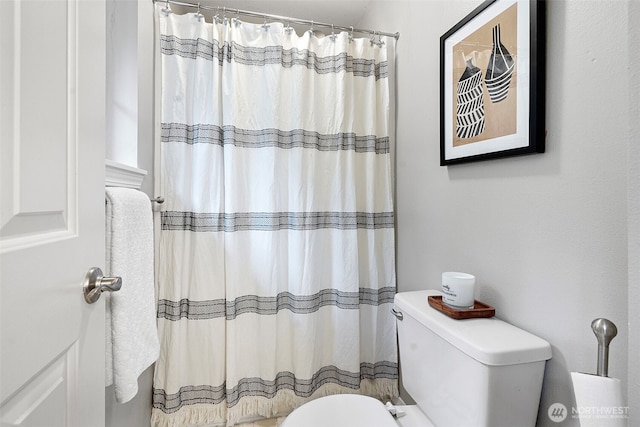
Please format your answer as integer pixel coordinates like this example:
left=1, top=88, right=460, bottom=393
left=0, top=1, right=76, bottom=247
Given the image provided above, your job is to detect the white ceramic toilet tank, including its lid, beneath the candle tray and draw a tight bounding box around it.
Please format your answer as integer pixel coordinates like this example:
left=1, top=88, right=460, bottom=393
left=394, top=290, right=551, bottom=427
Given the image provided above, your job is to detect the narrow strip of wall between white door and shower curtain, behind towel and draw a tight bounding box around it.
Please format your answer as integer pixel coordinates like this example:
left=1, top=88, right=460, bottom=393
left=105, top=0, right=155, bottom=427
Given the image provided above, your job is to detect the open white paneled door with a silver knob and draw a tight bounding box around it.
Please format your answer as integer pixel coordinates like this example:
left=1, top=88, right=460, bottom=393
left=0, top=0, right=105, bottom=427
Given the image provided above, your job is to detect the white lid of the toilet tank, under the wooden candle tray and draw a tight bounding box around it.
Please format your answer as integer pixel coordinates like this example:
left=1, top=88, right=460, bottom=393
left=394, top=290, right=551, bottom=366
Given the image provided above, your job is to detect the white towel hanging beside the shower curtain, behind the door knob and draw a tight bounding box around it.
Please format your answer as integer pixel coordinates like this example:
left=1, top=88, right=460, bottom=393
left=104, top=187, right=160, bottom=403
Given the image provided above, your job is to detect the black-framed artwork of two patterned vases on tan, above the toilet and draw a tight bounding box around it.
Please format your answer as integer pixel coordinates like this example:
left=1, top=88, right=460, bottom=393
left=440, top=0, right=546, bottom=166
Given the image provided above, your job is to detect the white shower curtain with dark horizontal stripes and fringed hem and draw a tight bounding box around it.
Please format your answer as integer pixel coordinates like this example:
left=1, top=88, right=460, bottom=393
left=152, top=6, right=398, bottom=426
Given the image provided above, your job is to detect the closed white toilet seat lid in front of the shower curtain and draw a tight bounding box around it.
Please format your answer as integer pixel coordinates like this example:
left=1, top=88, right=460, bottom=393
left=282, top=394, right=398, bottom=427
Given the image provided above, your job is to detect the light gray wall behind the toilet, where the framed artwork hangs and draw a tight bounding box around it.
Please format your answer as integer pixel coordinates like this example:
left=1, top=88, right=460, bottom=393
left=361, top=0, right=639, bottom=426
